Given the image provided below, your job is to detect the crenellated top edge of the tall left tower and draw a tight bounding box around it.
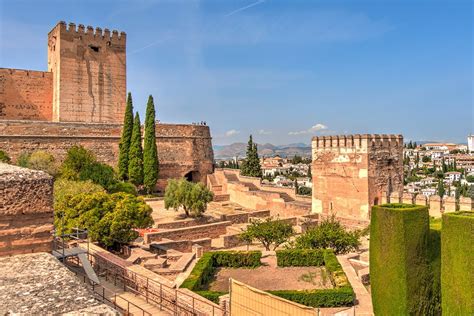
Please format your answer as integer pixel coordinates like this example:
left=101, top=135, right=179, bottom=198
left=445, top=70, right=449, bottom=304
left=48, top=21, right=127, bottom=45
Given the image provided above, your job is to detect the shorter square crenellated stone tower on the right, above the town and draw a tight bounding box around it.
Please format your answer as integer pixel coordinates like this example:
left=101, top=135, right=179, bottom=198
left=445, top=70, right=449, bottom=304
left=312, top=134, right=403, bottom=220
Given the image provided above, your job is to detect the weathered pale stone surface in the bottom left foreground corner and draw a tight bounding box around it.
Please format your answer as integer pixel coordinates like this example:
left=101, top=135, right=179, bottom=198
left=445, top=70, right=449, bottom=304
left=0, top=253, right=116, bottom=315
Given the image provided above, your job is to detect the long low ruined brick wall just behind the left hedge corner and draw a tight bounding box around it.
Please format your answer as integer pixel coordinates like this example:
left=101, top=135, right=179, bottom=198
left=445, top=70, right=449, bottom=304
left=143, top=221, right=232, bottom=244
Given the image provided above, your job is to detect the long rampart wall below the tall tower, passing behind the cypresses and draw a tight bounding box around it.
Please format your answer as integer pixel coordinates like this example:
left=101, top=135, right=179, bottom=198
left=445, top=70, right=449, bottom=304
left=0, top=120, right=214, bottom=190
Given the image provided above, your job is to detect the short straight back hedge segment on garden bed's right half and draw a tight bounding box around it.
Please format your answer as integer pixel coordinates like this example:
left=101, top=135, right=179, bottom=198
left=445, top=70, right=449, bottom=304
left=276, top=249, right=324, bottom=267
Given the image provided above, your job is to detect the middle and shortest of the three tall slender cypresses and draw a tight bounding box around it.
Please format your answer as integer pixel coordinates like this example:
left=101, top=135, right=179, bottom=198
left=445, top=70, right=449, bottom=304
left=128, top=112, right=143, bottom=186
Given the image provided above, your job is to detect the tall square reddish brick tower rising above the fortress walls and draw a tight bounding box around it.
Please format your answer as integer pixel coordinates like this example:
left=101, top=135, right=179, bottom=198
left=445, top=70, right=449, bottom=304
left=48, top=22, right=127, bottom=123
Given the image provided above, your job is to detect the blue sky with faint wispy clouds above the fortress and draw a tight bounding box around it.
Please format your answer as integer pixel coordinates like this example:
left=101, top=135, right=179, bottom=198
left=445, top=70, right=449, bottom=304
left=0, top=0, right=474, bottom=144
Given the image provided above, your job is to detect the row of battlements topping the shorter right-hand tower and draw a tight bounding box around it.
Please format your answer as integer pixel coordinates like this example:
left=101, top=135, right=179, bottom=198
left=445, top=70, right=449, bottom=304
left=312, top=134, right=403, bottom=150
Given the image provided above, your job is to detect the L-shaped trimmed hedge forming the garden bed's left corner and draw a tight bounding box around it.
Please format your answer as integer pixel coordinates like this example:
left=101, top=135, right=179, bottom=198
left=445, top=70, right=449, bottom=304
left=181, top=251, right=262, bottom=297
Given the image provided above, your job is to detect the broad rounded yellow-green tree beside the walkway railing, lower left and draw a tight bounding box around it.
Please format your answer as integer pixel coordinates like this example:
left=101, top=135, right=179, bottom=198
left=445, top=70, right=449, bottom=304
left=55, top=192, right=153, bottom=247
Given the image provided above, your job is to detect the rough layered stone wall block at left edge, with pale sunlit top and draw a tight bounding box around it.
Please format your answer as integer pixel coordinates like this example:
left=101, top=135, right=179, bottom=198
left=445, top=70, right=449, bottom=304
left=0, top=163, right=53, bottom=256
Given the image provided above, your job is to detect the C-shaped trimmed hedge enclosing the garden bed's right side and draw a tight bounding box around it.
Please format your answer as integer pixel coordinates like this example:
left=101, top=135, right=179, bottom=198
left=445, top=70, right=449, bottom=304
left=268, top=249, right=355, bottom=307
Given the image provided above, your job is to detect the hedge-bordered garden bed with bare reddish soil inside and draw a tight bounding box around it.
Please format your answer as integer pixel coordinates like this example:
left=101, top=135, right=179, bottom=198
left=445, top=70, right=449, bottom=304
left=181, top=250, right=355, bottom=307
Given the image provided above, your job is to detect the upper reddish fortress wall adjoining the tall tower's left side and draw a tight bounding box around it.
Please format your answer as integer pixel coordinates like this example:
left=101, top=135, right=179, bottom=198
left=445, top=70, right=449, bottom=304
left=0, top=68, right=53, bottom=121
